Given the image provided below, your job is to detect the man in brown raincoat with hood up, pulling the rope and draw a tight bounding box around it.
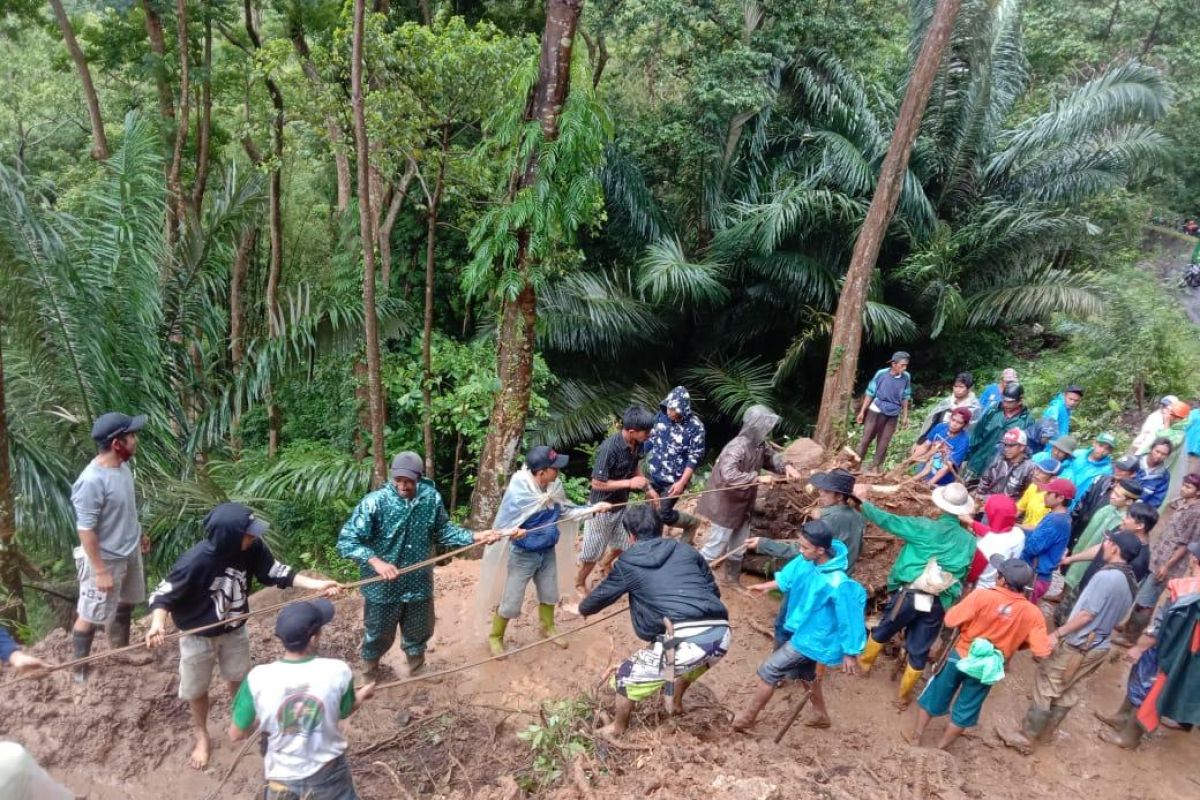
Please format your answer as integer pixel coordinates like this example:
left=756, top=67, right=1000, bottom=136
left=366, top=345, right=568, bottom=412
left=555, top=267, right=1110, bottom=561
left=696, top=405, right=799, bottom=583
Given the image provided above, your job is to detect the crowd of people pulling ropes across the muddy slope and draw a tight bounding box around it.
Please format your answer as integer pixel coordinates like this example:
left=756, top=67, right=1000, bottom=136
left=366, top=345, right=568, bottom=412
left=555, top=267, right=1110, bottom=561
left=7, top=371, right=1200, bottom=798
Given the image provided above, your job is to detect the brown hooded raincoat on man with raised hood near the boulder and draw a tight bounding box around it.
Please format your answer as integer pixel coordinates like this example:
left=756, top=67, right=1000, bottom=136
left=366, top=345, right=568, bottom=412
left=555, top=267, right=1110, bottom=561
left=696, top=405, right=787, bottom=529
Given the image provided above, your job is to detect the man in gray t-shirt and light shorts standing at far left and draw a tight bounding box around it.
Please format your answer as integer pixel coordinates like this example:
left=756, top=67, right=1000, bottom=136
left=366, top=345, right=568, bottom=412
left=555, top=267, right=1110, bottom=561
left=71, top=411, right=150, bottom=684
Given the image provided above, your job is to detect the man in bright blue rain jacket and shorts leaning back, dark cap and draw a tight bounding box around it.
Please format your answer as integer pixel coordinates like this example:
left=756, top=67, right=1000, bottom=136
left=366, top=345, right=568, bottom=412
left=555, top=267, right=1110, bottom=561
left=733, top=519, right=866, bottom=730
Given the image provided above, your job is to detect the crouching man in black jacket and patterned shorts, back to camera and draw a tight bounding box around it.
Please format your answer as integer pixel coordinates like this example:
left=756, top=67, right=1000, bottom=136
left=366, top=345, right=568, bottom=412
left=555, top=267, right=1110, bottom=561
left=580, top=505, right=732, bottom=736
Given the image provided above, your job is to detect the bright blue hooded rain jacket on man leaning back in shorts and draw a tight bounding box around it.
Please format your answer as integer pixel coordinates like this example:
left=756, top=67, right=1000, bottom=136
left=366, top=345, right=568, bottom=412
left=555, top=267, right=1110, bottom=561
left=775, top=539, right=866, bottom=667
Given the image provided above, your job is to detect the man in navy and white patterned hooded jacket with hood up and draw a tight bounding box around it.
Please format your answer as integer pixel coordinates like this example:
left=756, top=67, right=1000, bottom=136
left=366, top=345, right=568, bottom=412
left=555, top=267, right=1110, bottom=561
left=646, top=386, right=704, bottom=545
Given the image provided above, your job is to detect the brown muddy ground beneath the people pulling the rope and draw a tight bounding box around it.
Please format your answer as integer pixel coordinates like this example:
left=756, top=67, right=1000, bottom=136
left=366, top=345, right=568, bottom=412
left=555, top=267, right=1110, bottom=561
left=0, top=448, right=1200, bottom=800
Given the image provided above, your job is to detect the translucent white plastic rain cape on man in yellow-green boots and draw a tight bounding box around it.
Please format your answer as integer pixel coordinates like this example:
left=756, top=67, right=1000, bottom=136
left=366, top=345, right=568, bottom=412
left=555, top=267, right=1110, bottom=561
left=475, top=467, right=595, bottom=628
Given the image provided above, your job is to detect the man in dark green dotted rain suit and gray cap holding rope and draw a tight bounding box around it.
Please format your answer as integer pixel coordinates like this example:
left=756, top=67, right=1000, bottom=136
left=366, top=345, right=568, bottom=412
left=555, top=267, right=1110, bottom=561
left=337, top=452, right=499, bottom=681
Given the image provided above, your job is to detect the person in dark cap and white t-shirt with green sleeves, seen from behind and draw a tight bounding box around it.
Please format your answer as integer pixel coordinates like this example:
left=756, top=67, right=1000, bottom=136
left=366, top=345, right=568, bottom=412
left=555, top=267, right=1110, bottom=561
left=229, top=600, right=374, bottom=800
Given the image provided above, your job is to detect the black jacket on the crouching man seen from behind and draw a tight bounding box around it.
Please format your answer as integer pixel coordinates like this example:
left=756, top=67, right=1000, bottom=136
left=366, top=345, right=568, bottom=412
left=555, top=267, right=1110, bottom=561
left=580, top=539, right=730, bottom=642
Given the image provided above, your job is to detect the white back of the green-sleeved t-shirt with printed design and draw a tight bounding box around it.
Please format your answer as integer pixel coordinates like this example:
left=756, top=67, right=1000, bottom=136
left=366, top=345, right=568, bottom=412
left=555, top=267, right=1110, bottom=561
left=246, top=658, right=354, bottom=781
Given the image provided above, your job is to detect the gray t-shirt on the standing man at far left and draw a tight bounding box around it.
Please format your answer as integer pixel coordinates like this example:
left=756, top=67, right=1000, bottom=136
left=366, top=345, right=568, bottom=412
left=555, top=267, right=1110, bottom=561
left=71, top=462, right=142, bottom=559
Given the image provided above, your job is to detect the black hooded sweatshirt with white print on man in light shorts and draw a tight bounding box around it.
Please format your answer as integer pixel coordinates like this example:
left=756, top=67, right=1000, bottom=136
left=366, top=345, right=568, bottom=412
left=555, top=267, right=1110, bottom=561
left=150, top=520, right=295, bottom=636
